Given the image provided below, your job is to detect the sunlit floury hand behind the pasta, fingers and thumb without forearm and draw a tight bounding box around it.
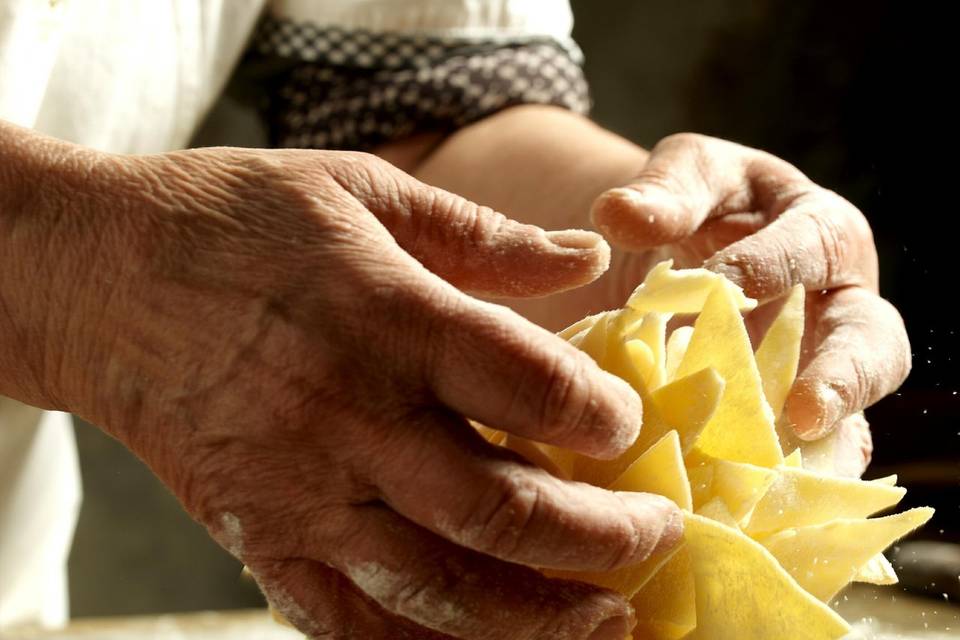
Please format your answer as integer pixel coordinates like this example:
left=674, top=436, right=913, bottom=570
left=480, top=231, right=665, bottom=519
left=592, top=134, right=910, bottom=473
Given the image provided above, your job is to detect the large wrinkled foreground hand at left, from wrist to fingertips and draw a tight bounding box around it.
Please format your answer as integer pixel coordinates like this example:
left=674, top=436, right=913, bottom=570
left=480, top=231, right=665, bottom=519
left=9, top=141, right=681, bottom=640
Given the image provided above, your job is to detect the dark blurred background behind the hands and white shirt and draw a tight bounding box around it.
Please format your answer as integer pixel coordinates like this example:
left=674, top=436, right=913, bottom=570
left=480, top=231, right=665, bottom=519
left=63, top=0, right=960, bottom=616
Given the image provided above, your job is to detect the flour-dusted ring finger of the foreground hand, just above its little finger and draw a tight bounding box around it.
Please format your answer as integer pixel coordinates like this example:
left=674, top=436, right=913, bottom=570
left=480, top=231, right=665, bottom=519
left=320, top=504, right=632, bottom=640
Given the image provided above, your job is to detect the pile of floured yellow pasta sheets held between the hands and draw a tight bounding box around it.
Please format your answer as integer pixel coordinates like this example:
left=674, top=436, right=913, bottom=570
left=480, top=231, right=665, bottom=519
left=478, top=262, right=933, bottom=640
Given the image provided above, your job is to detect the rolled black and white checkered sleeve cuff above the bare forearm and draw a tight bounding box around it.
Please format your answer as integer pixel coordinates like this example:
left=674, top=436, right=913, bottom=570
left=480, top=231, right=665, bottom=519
left=254, top=17, right=590, bottom=150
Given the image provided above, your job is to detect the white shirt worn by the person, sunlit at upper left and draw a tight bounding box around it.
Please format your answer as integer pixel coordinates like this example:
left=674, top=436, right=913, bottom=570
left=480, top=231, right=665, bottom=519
left=0, top=0, right=572, bottom=630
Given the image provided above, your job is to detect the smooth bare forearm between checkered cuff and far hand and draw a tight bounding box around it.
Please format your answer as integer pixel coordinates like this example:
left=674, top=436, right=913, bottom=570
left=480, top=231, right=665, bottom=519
left=404, top=105, right=647, bottom=228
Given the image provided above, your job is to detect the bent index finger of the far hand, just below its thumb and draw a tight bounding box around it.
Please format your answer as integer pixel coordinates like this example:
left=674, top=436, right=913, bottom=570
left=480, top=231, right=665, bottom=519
left=705, top=188, right=878, bottom=300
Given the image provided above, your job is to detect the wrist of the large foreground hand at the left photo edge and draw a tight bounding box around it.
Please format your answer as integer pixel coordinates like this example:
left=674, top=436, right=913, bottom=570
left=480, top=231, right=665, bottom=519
left=0, top=123, right=131, bottom=410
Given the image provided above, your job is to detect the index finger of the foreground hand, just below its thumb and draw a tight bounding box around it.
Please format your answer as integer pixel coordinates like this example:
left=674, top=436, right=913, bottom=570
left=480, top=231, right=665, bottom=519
left=428, top=300, right=643, bottom=458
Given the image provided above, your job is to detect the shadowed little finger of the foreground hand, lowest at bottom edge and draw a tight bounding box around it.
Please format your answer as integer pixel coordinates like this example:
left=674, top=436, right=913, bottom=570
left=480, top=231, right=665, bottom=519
left=250, top=558, right=452, bottom=640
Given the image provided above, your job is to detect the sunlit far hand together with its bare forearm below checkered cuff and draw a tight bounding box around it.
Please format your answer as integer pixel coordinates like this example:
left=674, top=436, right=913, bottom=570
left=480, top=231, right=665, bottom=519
left=415, top=106, right=910, bottom=475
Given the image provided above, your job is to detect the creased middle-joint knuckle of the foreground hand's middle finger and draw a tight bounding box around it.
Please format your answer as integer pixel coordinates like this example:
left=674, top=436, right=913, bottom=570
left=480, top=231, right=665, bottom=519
left=461, top=469, right=543, bottom=558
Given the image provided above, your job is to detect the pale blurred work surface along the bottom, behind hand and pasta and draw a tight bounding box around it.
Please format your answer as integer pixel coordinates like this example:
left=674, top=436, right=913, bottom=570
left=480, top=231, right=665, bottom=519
left=0, top=585, right=960, bottom=640
